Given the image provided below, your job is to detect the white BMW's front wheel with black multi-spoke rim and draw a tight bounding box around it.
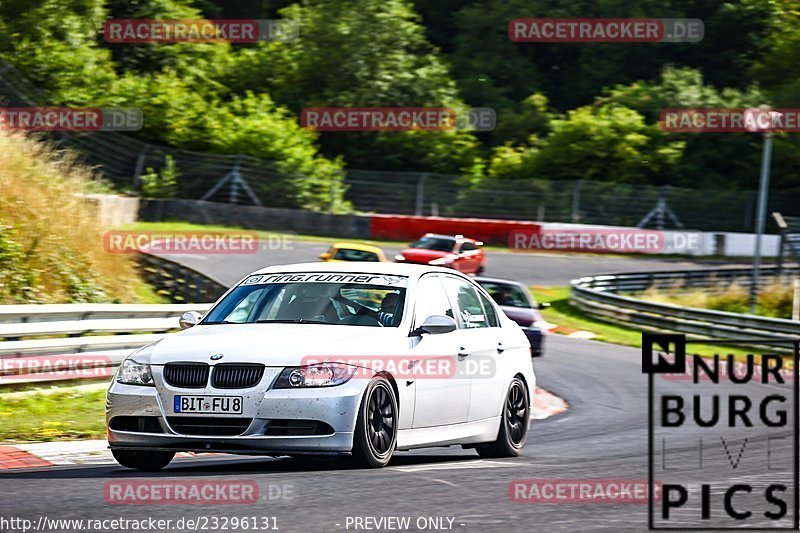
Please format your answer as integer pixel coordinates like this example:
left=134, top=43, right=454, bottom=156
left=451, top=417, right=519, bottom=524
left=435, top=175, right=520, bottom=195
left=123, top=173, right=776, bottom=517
left=353, top=377, right=397, bottom=468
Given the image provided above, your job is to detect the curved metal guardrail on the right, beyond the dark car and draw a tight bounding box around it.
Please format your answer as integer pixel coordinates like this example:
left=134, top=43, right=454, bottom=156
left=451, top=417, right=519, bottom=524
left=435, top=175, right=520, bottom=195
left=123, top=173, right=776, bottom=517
left=570, top=267, right=800, bottom=349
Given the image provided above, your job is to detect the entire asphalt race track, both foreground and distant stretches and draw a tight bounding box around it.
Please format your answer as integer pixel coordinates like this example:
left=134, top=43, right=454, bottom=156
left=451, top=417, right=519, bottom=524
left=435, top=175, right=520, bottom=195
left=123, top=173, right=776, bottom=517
left=0, top=249, right=780, bottom=532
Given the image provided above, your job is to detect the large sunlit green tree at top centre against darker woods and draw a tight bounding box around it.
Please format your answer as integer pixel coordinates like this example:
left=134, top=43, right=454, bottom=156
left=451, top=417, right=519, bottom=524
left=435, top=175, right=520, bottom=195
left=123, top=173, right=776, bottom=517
left=247, top=0, right=479, bottom=173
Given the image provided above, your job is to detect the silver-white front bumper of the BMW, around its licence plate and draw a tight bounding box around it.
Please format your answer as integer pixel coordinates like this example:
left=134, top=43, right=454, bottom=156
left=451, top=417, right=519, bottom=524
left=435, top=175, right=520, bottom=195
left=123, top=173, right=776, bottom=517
left=106, top=372, right=365, bottom=455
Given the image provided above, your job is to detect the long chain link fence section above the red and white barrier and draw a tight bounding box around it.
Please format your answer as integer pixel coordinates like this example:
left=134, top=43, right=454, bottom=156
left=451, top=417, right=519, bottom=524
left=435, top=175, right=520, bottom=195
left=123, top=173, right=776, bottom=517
left=346, top=170, right=800, bottom=232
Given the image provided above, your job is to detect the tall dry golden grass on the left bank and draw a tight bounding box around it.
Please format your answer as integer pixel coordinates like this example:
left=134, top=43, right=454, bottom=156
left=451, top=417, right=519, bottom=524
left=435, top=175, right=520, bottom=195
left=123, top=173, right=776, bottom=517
left=0, top=131, right=138, bottom=304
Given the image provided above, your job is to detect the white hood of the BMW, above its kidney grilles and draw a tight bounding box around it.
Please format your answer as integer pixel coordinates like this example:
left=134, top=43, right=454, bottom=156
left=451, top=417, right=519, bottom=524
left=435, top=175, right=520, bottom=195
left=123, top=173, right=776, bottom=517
left=133, top=324, right=408, bottom=366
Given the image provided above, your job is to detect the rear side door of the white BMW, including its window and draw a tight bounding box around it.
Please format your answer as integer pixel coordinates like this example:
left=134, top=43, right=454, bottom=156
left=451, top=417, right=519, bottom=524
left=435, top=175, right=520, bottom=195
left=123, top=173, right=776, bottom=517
left=445, top=275, right=504, bottom=422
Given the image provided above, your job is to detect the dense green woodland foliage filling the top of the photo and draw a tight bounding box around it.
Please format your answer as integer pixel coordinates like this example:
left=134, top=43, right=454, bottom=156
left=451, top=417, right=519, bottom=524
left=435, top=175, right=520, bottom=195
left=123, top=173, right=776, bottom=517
left=0, top=0, right=800, bottom=209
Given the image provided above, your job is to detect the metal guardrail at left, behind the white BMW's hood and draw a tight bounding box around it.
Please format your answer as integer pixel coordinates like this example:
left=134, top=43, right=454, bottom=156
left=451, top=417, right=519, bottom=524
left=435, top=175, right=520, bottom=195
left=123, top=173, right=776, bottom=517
left=0, top=254, right=226, bottom=385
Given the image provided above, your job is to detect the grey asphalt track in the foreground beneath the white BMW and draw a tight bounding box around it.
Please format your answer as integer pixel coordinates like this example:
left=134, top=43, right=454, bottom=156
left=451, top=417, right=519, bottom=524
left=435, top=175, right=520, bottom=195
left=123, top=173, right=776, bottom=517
left=0, top=337, right=791, bottom=532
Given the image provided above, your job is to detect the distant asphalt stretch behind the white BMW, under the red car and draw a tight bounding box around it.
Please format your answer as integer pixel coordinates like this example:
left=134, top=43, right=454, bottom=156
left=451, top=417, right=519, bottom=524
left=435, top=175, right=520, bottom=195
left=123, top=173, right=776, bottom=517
left=165, top=241, right=732, bottom=285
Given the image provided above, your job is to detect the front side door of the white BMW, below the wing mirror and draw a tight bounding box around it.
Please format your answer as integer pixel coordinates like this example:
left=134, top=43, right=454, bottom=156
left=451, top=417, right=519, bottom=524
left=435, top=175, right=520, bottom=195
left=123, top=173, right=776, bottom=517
left=405, top=274, right=470, bottom=428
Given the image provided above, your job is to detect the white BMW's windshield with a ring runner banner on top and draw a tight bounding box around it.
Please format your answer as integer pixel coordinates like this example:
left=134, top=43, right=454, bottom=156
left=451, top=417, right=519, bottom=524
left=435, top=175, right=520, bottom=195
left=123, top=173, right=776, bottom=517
left=202, top=273, right=406, bottom=327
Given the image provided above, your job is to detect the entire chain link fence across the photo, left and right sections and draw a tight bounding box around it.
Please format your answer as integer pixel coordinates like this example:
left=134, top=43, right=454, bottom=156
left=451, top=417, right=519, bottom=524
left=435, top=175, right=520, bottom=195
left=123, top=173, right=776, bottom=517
left=0, top=58, right=800, bottom=232
